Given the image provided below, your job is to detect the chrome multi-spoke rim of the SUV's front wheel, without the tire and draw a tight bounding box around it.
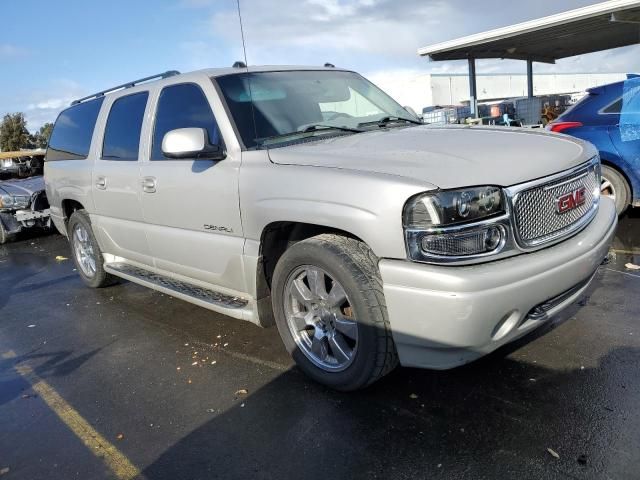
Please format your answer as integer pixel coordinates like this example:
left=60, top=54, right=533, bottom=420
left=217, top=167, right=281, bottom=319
left=284, top=265, right=358, bottom=372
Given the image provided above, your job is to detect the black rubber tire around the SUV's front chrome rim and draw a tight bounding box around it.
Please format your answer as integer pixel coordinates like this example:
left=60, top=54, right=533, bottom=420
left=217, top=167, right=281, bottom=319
left=272, top=234, right=398, bottom=391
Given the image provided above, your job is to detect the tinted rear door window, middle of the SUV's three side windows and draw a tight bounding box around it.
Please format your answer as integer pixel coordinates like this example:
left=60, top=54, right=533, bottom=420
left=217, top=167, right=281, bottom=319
left=102, top=92, right=149, bottom=160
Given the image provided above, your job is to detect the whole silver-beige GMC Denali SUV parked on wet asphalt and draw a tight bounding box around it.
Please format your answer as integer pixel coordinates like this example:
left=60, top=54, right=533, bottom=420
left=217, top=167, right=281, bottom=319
left=45, top=65, right=617, bottom=390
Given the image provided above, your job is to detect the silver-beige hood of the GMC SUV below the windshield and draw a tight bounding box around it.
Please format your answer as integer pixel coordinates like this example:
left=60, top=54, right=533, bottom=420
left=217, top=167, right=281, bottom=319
left=269, top=125, right=597, bottom=189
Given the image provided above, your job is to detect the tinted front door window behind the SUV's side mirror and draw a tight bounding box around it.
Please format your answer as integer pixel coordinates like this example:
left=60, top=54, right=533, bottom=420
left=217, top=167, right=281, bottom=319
left=151, top=83, right=220, bottom=160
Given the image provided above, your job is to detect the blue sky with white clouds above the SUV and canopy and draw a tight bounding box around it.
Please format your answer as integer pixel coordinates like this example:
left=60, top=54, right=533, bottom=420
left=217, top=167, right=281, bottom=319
left=0, top=0, right=640, bottom=130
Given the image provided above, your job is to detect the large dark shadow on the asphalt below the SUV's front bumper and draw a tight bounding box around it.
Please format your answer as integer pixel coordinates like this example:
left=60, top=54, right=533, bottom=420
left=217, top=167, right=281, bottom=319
left=143, top=347, right=640, bottom=480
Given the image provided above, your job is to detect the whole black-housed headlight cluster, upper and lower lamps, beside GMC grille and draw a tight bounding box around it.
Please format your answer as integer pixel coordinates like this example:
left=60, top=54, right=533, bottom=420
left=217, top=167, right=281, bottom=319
left=403, top=186, right=509, bottom=263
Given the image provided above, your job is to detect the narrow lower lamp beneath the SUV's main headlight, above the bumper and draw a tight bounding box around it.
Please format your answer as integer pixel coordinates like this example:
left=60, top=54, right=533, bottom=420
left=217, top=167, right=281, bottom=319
left=420, top=225, right=505, bottom=257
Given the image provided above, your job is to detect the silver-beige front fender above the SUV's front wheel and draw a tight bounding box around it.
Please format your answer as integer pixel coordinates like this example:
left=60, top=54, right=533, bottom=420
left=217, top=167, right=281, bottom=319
left=240, top=162, right=435, bottom=259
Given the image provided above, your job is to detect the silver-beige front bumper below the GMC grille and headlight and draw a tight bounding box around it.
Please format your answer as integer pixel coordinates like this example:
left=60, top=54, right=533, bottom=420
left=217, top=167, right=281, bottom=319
left=379, top=197, right=617, bottom=369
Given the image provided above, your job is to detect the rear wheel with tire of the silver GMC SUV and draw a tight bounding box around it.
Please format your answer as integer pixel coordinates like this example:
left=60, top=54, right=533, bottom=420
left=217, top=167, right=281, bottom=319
left=67, top=210, right=116, bottom=288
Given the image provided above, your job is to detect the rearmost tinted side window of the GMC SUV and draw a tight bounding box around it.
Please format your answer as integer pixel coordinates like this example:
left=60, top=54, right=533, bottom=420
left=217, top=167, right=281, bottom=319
left=46, top=98, right=104, bottom=161
